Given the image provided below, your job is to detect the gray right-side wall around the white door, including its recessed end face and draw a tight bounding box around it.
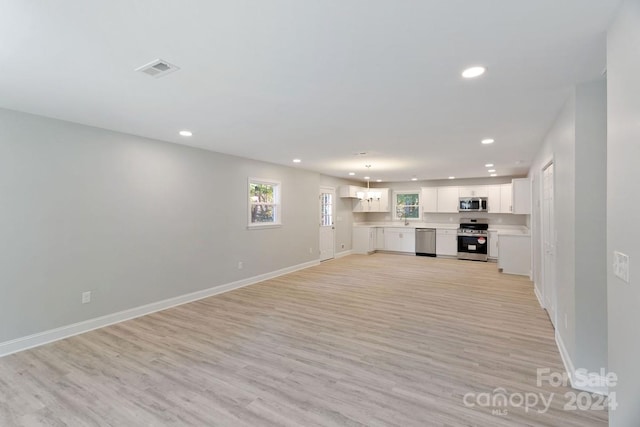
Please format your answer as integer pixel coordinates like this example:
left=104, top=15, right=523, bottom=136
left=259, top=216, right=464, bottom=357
left=529, top=80, right=607, bottom=372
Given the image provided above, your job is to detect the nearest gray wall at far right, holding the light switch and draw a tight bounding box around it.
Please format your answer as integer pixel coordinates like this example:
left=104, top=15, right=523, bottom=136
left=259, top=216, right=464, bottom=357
left=607, top=0, right=640, bottom=427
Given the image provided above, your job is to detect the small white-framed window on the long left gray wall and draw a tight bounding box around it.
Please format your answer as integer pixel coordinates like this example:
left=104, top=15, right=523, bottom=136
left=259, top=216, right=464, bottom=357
left=249, top=178, right=282, bottom=227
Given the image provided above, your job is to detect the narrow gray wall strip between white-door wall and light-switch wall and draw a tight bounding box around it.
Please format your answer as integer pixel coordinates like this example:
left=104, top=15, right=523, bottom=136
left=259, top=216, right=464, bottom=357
left=574, top=79, right=607, bottom=372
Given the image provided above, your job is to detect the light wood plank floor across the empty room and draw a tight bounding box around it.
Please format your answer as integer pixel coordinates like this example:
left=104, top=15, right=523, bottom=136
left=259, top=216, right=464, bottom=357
left=0, top=254, right=607, bottom=427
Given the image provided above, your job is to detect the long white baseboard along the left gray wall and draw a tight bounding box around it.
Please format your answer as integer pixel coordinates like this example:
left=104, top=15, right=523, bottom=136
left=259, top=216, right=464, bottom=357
left=0, top=260, right=320, bottom=357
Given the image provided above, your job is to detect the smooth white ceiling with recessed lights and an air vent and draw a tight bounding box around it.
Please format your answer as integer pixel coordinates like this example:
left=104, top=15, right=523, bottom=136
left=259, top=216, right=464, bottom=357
left=0, top=0, right=619, bottom=181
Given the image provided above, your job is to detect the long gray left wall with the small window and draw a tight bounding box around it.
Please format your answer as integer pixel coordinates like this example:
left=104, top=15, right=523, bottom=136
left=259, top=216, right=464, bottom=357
left=0, top=110, right=351, bottom=342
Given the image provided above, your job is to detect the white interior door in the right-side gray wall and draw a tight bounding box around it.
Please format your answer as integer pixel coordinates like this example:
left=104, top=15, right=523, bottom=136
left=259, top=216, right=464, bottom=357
left=542, top=164, right=556, bottom=327
